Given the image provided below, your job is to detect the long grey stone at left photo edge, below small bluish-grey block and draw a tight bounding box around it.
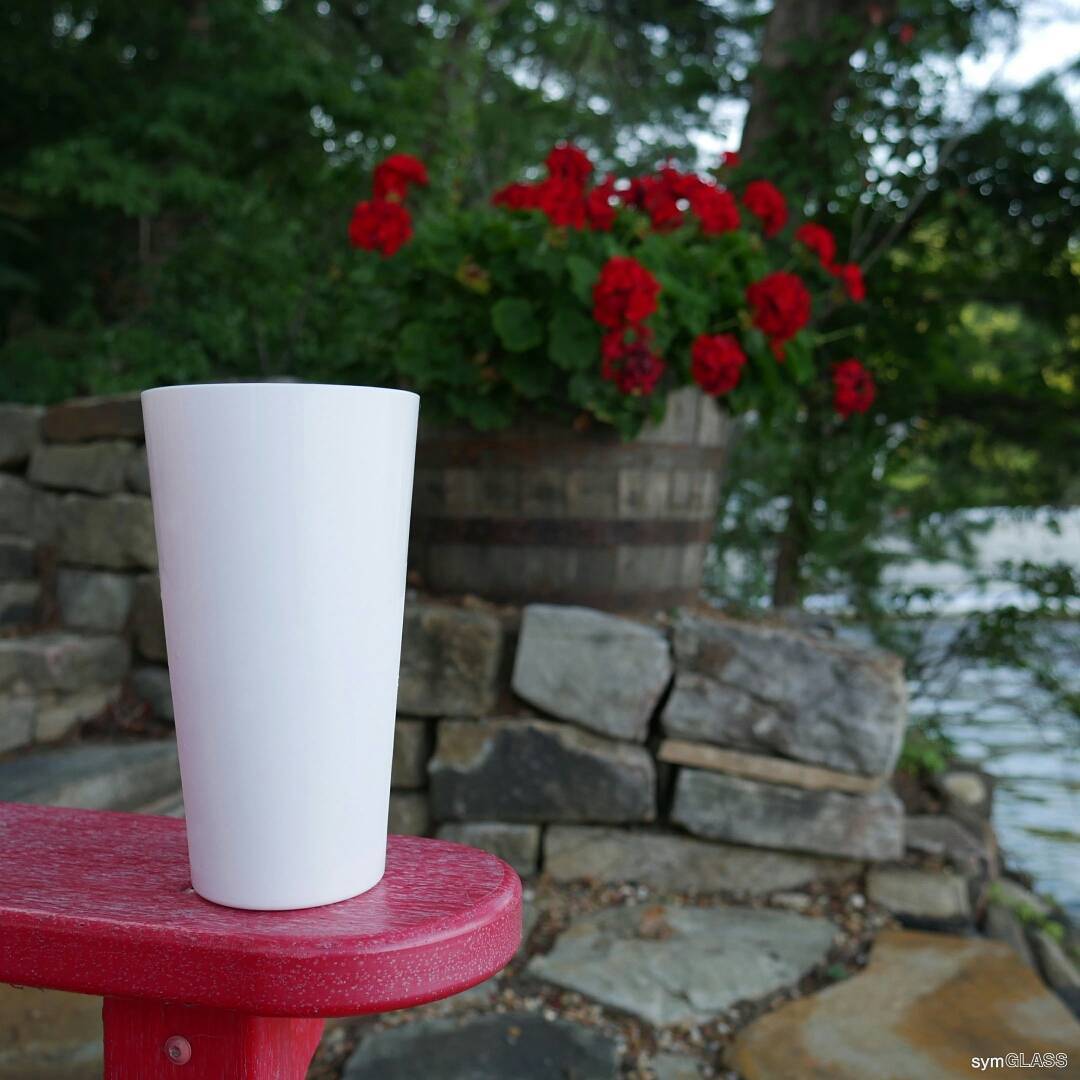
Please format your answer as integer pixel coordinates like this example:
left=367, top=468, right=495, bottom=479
left=0, top=632, right=130, bottom=692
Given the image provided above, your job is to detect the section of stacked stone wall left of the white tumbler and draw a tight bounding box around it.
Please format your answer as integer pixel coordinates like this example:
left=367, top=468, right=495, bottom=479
left=0, top=395, right=157, bottom=750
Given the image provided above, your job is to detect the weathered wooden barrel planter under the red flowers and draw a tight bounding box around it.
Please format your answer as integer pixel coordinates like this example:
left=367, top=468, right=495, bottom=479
left=410, top=388, right=730, bottom=610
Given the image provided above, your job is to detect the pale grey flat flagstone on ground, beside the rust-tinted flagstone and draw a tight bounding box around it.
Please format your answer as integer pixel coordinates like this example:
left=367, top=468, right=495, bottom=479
left=527, top=905, right=836, bottom=1025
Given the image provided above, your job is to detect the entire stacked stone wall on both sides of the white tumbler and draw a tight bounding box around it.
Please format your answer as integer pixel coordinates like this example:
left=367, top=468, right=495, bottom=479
left=0, top=396, right=906, bottom=891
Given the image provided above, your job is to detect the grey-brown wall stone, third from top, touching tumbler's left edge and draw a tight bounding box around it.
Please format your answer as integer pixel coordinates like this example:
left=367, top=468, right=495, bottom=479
left=55, top=495, right=158, bottom=570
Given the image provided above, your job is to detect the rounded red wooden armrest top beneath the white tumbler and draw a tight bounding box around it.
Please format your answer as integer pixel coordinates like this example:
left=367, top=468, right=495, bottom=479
left=0, top=802, right=522, bottom=1017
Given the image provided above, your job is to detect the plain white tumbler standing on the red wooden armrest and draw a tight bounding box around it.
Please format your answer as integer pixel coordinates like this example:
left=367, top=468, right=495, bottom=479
left=143, top=383, right=419, bottom=910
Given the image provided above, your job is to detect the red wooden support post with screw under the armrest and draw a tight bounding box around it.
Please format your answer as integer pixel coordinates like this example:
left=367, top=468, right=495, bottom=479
left=102, top=998, right=323, bottom=1080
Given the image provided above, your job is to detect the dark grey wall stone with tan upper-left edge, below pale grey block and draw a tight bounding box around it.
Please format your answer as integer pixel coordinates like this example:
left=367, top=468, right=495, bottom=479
left=428, top=719, right=656, bottom=823
